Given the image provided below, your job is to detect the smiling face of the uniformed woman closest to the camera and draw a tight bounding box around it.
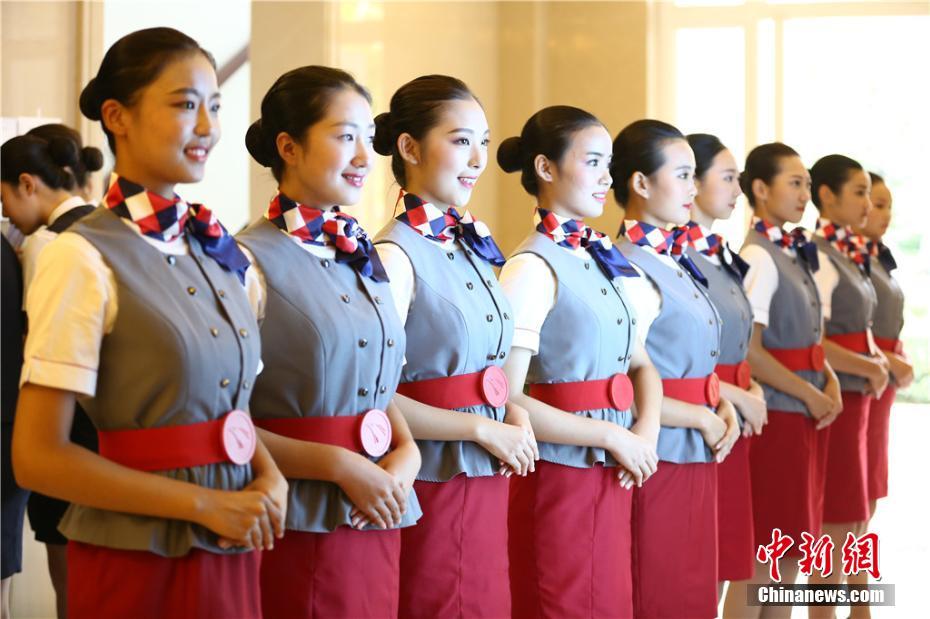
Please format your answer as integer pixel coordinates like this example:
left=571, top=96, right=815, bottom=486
left=101, top=52, right=220, bottom=196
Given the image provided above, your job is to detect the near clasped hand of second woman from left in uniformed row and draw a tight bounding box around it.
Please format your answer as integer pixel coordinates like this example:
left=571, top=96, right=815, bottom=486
left=336, top=454, right=407, bottom=529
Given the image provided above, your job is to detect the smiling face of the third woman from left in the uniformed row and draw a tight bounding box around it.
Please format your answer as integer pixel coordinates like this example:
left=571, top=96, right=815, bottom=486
left=398, top=98, right=490, bottom=209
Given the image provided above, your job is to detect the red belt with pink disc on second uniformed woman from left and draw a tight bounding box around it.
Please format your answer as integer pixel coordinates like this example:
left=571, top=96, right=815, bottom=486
left=255, top=408, right=392, bottom=458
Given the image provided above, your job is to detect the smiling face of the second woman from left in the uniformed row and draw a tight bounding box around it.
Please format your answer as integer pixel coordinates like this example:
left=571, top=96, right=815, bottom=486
left=279, top=88, right=375, bottom=208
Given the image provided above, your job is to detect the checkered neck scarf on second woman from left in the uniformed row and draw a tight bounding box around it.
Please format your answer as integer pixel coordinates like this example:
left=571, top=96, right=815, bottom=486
left=265, top=193, right=388, bottom=282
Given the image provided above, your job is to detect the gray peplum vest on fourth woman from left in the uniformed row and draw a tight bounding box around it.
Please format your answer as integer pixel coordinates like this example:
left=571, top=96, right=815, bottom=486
left=513, top=232, right=636, bottom=467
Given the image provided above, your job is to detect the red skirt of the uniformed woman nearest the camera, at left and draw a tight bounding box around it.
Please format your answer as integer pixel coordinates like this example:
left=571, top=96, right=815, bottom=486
left=68, top=542, right=262, bottom=619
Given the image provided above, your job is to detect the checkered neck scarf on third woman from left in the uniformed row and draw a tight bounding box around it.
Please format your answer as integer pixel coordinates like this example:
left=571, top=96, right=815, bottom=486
left=397, top=190, right=504, bottom=267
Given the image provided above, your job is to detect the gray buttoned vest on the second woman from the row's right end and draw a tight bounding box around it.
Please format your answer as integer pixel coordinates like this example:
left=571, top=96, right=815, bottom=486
left=814, top=236, right=878, bottom=393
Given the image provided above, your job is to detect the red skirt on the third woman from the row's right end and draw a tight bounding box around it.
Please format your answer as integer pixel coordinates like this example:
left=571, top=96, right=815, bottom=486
left=749, top=410, right=830, bottom=556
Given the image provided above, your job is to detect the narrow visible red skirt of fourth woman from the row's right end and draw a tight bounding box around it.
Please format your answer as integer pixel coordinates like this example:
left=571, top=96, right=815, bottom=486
left=717, top=438, right=756, bottom=582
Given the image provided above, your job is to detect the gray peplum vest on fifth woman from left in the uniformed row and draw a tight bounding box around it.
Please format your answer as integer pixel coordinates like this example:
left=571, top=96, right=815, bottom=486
left=617, top=238, right=720, bottom=463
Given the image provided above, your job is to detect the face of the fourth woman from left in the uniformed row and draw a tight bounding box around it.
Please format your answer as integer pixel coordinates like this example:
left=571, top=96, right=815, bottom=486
left=540, top=125, right=611, bottom=219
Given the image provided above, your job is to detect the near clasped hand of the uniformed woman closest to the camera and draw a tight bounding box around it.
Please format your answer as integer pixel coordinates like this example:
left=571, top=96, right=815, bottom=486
left=196, top=488, right=274, bottom=550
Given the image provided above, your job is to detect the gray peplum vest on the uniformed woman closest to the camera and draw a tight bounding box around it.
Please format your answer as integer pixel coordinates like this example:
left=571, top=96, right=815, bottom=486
left=59, top=208, right=260, bottom=557
